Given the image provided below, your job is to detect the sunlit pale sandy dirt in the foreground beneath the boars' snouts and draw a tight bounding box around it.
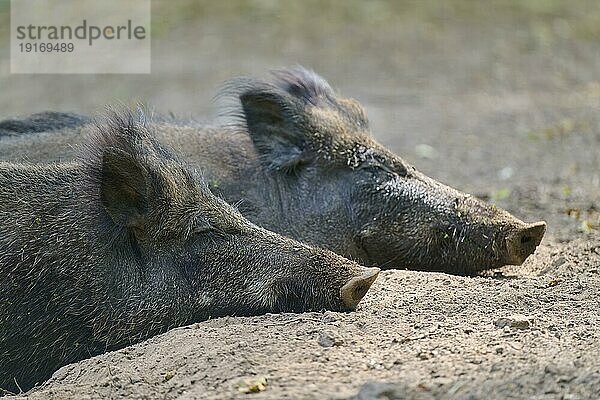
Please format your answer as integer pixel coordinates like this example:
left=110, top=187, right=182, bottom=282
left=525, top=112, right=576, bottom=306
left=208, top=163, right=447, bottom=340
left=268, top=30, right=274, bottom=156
left=12, top=236, right=600, bottom=399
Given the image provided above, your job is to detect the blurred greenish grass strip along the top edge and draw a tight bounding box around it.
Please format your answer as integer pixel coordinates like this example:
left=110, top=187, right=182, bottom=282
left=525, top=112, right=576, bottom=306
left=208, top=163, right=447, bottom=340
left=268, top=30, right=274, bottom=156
left=0, top=0, right=600, bottom=47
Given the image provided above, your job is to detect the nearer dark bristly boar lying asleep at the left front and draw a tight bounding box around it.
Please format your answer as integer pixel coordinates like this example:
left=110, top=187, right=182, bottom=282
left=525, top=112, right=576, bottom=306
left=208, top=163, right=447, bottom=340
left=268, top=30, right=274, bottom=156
left=0, top=115, right=378, bottom=393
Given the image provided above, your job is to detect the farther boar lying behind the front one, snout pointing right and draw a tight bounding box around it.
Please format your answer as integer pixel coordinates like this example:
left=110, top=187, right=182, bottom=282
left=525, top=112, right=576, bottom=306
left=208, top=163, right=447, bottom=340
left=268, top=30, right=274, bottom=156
left=0, top=68, right=545, bottom=274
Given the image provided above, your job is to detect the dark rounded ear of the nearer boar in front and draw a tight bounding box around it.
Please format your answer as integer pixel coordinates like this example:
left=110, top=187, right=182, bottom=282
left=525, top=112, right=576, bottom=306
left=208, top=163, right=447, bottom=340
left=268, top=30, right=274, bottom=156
left=100, top=147, right=149, bottom=227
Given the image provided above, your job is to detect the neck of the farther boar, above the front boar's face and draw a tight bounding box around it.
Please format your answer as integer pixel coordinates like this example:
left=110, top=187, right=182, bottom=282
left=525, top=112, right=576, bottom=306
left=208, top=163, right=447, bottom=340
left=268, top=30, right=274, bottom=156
left=156, top=125, right=365, bottom=259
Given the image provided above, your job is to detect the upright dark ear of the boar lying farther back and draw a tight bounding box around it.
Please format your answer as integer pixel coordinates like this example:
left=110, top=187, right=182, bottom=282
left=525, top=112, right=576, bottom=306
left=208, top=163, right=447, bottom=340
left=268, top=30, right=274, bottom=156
left=240, top=89, right=307, bottom=171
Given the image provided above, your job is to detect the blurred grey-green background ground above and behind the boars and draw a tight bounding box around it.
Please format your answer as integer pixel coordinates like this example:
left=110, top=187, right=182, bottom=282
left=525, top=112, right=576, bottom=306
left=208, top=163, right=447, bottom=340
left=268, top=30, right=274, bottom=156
left=0, top=0, right=600, bottom=241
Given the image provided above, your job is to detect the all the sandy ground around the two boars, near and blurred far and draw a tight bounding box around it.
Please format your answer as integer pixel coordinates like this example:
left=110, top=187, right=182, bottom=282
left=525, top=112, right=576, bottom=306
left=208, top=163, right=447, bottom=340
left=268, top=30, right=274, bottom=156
left=0, top=0, right=600, bottom=399
